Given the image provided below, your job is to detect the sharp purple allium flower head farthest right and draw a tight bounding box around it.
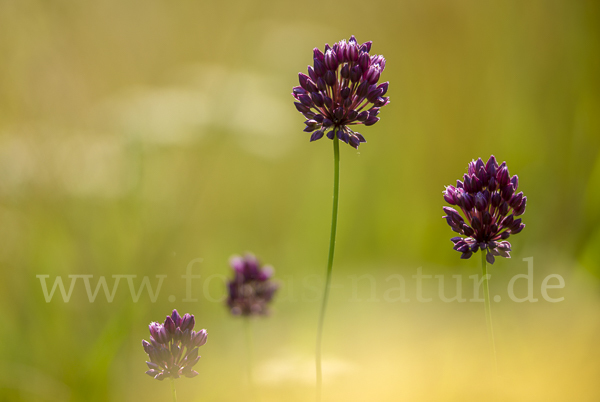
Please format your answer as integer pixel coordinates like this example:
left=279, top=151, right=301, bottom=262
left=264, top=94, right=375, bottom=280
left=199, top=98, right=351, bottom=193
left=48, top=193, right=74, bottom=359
left=444, top=155, right=527, bottom=264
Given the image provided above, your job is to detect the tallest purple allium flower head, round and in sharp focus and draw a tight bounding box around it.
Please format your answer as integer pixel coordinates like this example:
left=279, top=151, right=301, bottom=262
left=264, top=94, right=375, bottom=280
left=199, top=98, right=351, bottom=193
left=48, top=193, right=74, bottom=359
left=292, top=35, right=389, bottom=148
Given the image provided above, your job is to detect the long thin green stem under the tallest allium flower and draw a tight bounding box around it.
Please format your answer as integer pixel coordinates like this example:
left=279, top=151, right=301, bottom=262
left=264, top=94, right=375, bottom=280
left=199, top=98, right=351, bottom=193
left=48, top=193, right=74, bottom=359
left=316, top=136, right=340, bottom=402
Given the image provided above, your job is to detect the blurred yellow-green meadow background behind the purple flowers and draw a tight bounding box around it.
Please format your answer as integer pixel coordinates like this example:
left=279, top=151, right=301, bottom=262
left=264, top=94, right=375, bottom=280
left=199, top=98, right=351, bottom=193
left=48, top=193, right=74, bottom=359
left=0, top=0, right=600, bottom=401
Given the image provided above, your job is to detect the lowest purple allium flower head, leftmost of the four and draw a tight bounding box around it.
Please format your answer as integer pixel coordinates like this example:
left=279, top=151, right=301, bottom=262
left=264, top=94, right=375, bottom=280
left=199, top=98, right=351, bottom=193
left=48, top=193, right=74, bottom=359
left=142, top=310, right=207, bottom=381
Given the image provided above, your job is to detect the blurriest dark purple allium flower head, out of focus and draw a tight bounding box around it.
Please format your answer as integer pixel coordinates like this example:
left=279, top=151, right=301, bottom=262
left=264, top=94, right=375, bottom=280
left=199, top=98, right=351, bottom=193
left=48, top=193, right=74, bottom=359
left=227, top=254, right=277, bottom=316
